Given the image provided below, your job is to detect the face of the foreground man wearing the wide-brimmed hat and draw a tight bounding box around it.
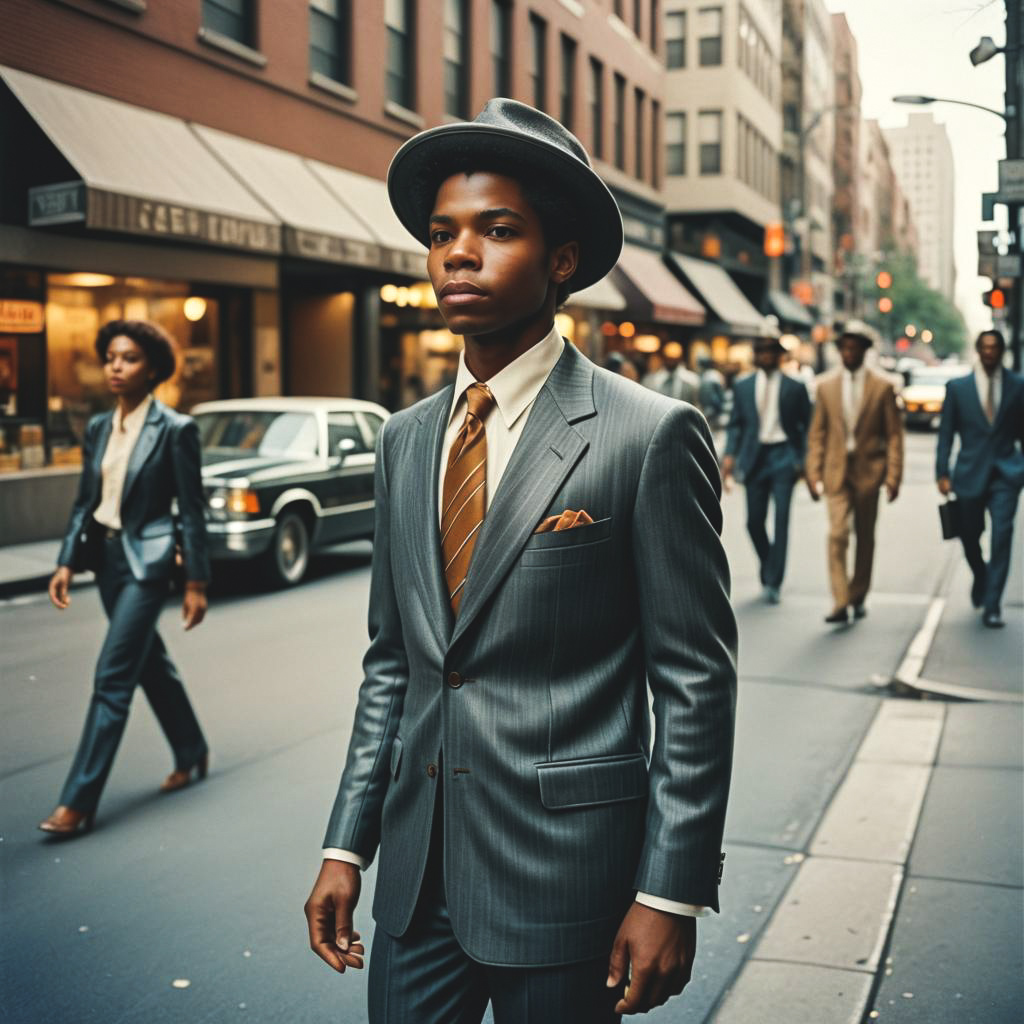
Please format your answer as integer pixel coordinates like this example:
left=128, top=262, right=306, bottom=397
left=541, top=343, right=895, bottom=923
left=427, top=171, right=578, bottom=338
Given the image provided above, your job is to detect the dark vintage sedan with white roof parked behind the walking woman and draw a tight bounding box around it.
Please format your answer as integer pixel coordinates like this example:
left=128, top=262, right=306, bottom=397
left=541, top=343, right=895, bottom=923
left=191, top=398, right=388, bottom=586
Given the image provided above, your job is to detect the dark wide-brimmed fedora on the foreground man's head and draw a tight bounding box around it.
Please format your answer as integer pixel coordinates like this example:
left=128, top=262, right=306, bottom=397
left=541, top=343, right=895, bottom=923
left=387, top=98, right=623, bottom=292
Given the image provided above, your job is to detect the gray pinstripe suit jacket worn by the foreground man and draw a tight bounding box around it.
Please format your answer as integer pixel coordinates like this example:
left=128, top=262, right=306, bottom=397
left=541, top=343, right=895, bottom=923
left=325, top=345, right=736, bottom=966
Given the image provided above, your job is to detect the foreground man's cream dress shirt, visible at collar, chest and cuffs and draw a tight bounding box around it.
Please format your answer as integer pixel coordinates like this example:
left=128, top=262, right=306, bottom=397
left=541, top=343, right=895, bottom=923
left=323, top=327, right=711, bottom=918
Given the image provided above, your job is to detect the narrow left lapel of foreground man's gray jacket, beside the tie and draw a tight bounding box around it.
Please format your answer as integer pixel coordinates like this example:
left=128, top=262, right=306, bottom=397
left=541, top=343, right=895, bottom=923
left=412, top=387, right=454, bottom=648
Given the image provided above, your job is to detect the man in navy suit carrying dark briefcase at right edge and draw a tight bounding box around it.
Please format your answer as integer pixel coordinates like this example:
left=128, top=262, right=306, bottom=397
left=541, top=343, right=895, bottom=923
left=935, top=331, right=1024, bottom=629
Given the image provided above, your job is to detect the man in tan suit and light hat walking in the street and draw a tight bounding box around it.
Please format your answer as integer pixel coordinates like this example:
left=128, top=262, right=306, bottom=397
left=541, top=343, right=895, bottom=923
left=807, top=321, right=903, bottom=623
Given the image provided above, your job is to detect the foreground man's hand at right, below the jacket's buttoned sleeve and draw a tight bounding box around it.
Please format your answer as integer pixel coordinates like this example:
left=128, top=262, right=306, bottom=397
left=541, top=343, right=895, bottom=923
left=607, top=903, right=697, bottom=1015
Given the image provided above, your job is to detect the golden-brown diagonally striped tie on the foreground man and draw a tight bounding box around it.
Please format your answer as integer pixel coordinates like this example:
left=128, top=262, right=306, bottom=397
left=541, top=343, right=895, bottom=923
left=441, top=384, right=495, bottom=614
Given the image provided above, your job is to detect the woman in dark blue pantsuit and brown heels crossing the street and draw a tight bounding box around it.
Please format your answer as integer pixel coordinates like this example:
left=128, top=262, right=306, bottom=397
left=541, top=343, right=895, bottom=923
left=39, top=319, right=210, bottom=837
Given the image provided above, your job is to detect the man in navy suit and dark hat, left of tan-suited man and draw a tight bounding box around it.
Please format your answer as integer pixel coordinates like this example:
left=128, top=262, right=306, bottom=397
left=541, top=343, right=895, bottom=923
left=722, top=338, right=811, bottom=604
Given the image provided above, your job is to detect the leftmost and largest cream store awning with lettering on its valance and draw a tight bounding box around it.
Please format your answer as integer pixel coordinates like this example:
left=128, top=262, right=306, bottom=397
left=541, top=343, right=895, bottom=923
left=0, top=66, right=282, bottom=254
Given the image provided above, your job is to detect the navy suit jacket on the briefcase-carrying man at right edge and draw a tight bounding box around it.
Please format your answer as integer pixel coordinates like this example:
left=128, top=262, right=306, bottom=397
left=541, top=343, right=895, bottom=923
left=935, top=368, right=1024, bottom=498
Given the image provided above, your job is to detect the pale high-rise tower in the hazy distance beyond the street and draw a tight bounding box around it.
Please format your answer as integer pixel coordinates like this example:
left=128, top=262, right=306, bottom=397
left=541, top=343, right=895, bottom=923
left=884, top=113, right=956, bottom=301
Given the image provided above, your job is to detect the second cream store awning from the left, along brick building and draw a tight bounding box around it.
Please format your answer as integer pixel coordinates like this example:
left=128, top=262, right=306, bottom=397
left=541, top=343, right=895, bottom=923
left=194, top=125, right=382, bottom=266
